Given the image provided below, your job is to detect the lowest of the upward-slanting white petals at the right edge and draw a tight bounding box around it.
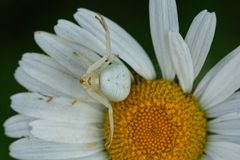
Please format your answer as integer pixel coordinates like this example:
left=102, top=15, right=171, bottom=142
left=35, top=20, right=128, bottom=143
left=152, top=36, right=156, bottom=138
left=206, top=92, right=240, bottom=118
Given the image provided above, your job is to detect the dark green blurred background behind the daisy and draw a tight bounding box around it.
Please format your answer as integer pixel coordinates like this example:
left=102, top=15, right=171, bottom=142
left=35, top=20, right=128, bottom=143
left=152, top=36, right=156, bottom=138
left=0, top=0, right=240, bottom=160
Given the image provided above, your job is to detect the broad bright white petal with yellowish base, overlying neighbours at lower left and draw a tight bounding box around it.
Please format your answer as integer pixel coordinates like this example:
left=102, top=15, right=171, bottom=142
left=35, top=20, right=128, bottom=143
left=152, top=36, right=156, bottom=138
left=30, top=120, right=103, bottom=144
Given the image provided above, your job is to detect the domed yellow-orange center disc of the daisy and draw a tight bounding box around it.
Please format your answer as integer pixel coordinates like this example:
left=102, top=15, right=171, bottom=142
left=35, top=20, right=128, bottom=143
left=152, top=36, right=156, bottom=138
left=104, top=80, right=206, bottom=160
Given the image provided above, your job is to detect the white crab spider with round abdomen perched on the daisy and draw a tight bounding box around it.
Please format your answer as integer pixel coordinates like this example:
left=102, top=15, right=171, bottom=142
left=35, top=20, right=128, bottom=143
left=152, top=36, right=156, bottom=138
left=80, top=14, right=131, bottom=145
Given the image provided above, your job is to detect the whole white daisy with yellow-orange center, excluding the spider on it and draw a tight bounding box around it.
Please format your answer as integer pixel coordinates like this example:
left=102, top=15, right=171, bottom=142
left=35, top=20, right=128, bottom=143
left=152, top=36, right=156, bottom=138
left=4, top=0, right=240, bottom=160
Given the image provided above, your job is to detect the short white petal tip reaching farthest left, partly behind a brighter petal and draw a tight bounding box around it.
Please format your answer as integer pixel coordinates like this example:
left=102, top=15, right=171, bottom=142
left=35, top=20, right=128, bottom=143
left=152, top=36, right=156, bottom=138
left=4, top=115, right=33, bottom=138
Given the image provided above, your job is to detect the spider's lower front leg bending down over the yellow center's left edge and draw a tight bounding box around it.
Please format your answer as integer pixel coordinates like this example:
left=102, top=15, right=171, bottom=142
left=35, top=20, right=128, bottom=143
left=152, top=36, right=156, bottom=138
left=87, top=89, right=114, bottom=147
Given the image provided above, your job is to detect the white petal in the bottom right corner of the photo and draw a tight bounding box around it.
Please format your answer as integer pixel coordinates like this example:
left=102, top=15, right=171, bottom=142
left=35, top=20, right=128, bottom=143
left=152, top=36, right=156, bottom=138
left=205, top=142, right=240, bottom=160
